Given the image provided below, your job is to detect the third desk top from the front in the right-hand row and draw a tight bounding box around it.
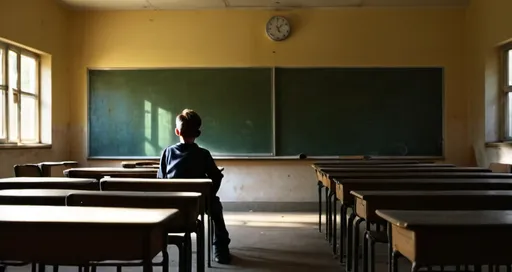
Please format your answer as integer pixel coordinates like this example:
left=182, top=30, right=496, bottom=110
left=334, top=177, right=512, bottom=184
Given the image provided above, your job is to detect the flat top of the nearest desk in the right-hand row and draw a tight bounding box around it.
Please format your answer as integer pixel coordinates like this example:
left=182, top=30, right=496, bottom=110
left=376, top=210, right=512, bottom=228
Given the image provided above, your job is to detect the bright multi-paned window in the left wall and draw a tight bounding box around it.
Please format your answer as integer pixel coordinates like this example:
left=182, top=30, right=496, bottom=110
left=0, top=43, right=41, bottom=144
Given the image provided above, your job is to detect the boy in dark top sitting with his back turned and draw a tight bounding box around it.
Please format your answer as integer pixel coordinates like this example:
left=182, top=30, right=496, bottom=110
left=157, top=109, right=231, bottom=264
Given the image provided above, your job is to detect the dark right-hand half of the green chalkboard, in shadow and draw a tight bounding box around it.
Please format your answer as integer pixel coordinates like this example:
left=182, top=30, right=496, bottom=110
left=275, top=68, right=443, bottom=156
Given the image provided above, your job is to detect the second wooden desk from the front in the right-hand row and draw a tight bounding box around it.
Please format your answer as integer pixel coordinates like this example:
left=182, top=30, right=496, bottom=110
left=351, top=190, right=512, bottom=272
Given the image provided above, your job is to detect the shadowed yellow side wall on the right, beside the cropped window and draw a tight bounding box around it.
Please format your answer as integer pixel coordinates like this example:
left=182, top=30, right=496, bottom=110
left=465, top=0, right=512, bottom=166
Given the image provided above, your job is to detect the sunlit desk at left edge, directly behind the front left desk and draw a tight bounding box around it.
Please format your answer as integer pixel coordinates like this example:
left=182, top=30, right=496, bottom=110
left=0, top=189, right=82, bottom=206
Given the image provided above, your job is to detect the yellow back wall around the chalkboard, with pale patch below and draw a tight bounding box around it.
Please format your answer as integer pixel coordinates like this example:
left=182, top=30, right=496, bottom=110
left=70, top=8, right=472, bottom=202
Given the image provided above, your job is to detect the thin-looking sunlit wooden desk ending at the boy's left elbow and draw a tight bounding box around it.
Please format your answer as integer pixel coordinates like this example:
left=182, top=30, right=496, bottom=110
left=64, top=167, right=158, bottom=180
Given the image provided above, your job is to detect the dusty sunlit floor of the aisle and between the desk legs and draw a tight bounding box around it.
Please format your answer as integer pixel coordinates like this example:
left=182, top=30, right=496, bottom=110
left=3, top=213, right=440, bottom=272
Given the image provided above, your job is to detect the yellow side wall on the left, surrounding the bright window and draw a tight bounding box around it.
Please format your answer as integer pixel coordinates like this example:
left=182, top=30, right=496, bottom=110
left=0, top=0, right=71, bottom=177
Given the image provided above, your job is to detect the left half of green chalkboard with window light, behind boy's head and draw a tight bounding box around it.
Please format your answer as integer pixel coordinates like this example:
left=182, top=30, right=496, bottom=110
left=88, top=68, right=273, bottom=157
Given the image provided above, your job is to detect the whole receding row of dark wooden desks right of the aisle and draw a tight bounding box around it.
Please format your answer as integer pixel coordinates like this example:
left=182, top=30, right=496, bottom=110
left=313, top=161, right=512, bottom=272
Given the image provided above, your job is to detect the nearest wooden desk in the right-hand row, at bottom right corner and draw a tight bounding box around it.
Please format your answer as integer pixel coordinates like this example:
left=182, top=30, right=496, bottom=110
left=377, top=210, right=512, bottom=272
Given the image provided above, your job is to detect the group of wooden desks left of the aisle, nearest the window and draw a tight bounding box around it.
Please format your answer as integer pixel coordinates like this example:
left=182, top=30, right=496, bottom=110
left=4, top=167, right=223, bottom=271
